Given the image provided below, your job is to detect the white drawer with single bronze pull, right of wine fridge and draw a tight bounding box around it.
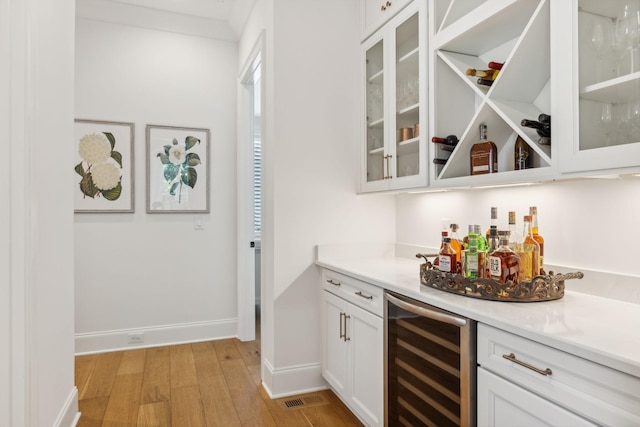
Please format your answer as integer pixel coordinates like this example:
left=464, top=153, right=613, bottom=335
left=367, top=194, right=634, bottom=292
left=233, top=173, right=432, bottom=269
left=477, top=324, right=640, bottom=426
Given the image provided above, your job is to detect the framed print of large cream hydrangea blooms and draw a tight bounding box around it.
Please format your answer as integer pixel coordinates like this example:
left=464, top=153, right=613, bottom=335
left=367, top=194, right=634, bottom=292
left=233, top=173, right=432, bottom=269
left=74, top=119, right=135, bottom=213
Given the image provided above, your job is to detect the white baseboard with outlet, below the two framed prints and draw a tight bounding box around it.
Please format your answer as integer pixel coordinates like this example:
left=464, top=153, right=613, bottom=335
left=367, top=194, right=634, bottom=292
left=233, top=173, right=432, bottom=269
left=75, top=319, right=238, bottom=355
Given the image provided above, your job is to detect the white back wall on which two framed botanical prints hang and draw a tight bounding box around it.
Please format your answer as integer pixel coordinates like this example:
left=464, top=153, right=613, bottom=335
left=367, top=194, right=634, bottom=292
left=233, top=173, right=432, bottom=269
left=74, top=18, right=238, bottom=353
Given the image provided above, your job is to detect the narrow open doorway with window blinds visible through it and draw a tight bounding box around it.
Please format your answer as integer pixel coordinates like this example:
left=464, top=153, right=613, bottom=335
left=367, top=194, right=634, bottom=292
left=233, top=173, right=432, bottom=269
left=238, top=37, right=264, bottom=343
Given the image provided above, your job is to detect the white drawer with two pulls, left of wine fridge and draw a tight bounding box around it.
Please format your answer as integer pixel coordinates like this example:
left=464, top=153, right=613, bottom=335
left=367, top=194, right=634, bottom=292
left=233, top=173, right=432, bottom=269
left=322, top=270, right=383, bottom=317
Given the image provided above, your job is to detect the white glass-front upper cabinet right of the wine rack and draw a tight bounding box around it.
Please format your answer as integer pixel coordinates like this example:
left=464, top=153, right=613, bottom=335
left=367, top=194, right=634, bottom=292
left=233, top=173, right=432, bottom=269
left=553, top=0, right=640, bottom=173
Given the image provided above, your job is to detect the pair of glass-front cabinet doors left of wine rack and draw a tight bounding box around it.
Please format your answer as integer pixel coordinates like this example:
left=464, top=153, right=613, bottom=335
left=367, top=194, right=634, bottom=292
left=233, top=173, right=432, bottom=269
left=360, top=0, right=427, bottom=192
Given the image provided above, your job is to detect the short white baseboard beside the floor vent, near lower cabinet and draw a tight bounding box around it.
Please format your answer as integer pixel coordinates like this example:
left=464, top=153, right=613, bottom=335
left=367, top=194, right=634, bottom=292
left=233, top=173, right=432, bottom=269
left=262, top=359, right=329, bottom=399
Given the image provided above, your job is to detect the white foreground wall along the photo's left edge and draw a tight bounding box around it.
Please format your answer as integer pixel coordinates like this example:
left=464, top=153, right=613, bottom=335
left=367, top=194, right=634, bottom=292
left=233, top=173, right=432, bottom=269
left=0, top=0, right=77, bottom=426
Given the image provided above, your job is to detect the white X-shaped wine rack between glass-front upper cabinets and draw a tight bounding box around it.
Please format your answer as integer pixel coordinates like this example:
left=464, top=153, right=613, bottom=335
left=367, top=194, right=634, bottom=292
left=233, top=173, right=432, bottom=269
left=430, top=0, right=554, bottom=186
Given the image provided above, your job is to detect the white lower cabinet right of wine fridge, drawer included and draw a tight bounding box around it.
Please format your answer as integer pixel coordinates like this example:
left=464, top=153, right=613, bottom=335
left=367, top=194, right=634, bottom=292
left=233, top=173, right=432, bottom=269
left=477, top=324, right=640, bottom=427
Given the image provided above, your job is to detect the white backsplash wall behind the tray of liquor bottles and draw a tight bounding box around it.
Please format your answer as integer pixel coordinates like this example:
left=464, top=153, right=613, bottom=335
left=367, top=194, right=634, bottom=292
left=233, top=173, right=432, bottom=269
left=396, top=176, right=640, bottom=276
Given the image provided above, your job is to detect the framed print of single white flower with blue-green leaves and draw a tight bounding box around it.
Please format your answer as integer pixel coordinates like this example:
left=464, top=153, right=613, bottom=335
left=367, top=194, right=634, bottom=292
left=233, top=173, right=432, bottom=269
left=146, top=125, right=210, bottom=213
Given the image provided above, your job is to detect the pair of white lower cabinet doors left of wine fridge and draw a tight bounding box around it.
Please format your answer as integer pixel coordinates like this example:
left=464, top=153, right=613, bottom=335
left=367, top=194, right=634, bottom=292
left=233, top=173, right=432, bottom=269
left=322, top=274, right=384, bottom=426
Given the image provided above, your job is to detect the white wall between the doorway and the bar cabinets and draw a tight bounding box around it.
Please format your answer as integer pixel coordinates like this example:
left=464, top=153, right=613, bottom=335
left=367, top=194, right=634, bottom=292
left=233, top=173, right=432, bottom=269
left=240, top=0, right=395, bottom=395
